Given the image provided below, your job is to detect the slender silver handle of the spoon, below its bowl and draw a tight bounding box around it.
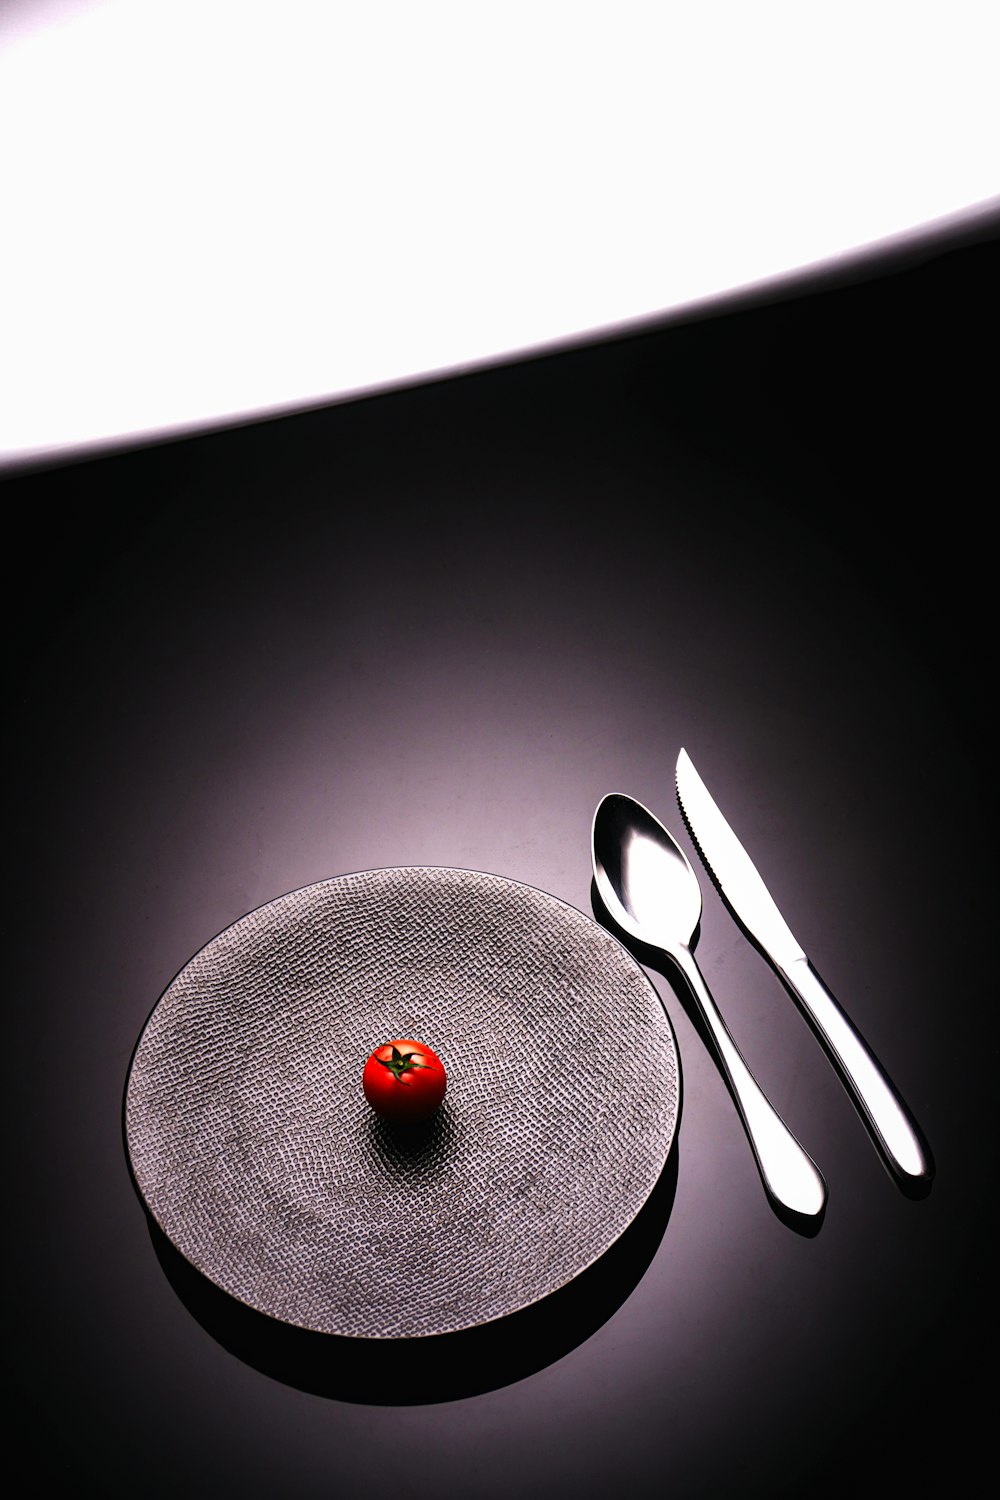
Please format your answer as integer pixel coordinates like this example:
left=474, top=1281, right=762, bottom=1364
left=670, top=948, right=826, bottom=1217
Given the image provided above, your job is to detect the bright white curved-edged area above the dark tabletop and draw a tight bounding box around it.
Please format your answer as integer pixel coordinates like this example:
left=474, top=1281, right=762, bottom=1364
left=0, top=0, right=1000, bottom=464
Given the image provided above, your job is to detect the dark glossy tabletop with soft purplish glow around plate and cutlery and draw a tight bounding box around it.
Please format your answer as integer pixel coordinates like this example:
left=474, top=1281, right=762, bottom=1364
left=7, top=222, right=999, bottom=1500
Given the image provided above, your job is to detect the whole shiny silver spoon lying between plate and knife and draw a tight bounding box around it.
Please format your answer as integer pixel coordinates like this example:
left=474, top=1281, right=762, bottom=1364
left=592, top=792, right=826, bottom=1217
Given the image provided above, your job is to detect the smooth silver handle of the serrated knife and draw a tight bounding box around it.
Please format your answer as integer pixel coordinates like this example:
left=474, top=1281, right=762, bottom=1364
left=780, top=957, right=934, bottom=1188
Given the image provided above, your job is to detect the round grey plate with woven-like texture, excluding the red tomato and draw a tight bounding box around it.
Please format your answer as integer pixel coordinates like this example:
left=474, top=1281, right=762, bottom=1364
left=124, top=867, right=679, bottom=1338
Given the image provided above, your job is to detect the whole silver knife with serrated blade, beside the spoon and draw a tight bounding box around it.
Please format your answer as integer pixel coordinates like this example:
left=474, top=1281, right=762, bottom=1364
left=676, top=749, right=934, bottom=1194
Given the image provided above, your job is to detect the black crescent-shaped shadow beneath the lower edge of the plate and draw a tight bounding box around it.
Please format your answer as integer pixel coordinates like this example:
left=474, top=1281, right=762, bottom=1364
left=147, top=1136, right=678, bottom=1406
